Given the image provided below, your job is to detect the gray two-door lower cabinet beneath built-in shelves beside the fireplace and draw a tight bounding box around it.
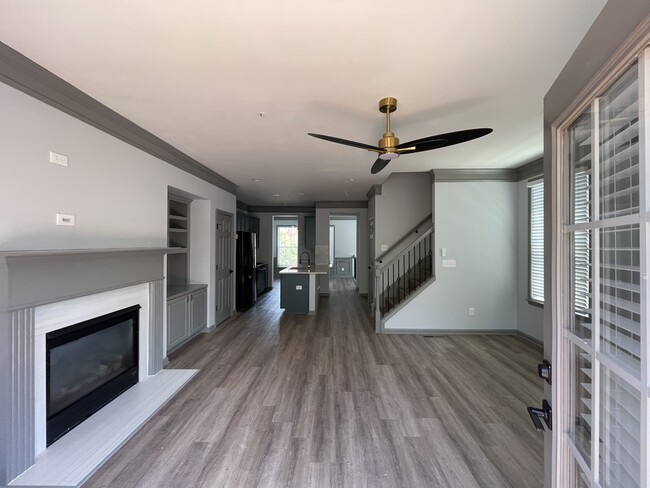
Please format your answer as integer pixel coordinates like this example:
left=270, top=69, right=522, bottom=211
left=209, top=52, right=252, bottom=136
left=167, top=288, right=208, bottom=353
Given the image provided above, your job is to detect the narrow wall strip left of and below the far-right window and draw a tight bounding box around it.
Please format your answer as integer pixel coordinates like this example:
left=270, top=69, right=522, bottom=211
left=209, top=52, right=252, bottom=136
left=517, top=177, right=544, bottom=341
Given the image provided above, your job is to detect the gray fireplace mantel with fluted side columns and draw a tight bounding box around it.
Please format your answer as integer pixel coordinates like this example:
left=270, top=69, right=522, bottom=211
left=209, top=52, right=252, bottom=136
left=0, top=248, right=168, bottom=486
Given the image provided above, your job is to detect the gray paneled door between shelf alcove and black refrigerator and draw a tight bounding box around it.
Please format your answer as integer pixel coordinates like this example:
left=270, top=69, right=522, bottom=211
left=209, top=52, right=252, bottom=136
left=214, top=210, right=234, bottom=325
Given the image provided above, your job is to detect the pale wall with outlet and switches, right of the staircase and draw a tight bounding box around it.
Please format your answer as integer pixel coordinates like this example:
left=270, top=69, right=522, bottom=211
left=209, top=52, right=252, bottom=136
left=385, top=182, right=517, bottom=330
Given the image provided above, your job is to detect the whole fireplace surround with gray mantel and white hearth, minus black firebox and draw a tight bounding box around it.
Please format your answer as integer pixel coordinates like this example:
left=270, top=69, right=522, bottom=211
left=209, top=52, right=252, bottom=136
left=0, top=249, right=194, bottom=486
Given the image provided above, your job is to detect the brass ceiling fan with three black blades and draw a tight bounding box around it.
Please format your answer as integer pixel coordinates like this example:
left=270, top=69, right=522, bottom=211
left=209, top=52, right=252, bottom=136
left=308, top=97, right=492, bottom=175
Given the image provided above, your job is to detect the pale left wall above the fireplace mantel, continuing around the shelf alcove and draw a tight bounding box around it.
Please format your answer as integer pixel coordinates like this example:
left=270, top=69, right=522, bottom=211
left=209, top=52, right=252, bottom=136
left=0, top=84, right=236, bottom=332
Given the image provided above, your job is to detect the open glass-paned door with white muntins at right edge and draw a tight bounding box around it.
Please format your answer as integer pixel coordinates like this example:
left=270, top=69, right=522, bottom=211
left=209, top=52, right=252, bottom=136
left=553, top=48, right=650, bottom=488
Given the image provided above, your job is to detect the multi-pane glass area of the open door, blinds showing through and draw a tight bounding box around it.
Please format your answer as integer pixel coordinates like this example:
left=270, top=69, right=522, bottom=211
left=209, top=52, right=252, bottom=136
left=564, top=56, right=650, bottom=488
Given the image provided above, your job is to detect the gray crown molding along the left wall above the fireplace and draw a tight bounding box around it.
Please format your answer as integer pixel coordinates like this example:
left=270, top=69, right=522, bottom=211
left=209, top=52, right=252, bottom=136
left=0, top=42, right=238, bottom=195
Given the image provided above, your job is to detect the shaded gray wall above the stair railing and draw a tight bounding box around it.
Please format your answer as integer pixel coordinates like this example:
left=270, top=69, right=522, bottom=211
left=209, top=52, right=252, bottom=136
left=374, top=172, right=431, bottom=256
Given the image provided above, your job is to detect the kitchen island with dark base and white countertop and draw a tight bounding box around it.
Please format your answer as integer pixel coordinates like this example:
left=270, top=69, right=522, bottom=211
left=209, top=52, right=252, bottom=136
left=280, top=264, right=329, bottom=315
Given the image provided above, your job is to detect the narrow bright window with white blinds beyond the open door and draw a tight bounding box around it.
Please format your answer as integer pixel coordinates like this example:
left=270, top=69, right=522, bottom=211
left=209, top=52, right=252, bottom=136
left=528, top=180, right=544, bottom=303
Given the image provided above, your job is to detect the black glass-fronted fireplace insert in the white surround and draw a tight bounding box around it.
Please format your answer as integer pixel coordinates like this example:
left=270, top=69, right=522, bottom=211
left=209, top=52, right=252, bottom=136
left=46, top=305, right=140, bottom=446
